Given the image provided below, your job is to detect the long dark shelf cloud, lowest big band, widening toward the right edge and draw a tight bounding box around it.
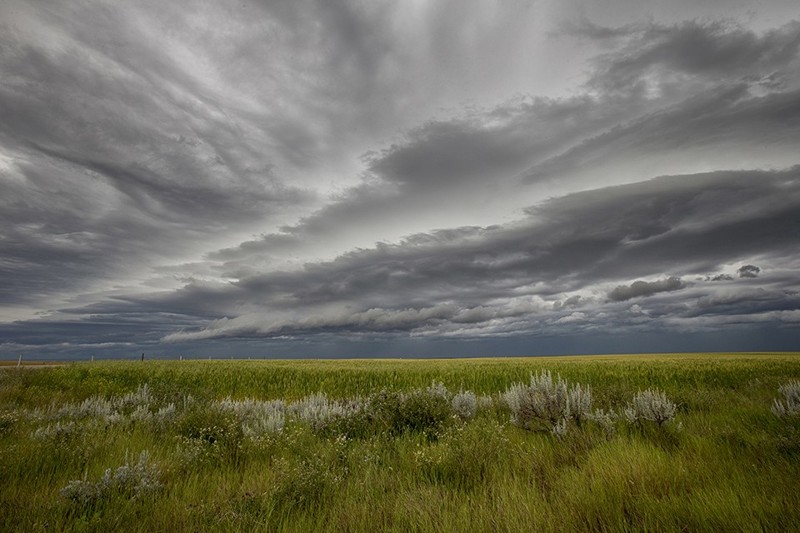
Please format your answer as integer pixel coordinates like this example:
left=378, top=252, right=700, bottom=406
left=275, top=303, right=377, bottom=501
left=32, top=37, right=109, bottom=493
left=162, top=168, right=800, bottom=340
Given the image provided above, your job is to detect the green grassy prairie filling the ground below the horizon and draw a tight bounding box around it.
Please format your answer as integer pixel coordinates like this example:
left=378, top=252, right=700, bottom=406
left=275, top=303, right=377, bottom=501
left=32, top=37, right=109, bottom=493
left=0, top=354, right=800, bottom=531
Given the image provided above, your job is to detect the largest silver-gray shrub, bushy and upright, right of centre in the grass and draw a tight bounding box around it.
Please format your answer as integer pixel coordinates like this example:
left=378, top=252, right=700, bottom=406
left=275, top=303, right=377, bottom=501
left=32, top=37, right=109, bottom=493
left=503, top=370, right=592, bottom=434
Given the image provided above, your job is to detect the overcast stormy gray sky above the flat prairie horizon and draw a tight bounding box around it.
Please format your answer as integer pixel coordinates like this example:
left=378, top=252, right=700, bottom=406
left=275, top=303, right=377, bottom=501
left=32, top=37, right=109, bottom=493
left=0, top=0, right=800, bottom=359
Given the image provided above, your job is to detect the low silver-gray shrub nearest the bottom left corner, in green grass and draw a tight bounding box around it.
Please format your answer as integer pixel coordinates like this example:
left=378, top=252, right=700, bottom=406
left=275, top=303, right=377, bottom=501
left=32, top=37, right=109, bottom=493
left=61, top=451, right=161, bottom=505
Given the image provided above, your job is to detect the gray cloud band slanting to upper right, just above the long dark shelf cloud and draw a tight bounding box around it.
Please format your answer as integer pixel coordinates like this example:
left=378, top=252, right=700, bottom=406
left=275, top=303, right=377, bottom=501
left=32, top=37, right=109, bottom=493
left=216, top=17, right=800, bottom=274
